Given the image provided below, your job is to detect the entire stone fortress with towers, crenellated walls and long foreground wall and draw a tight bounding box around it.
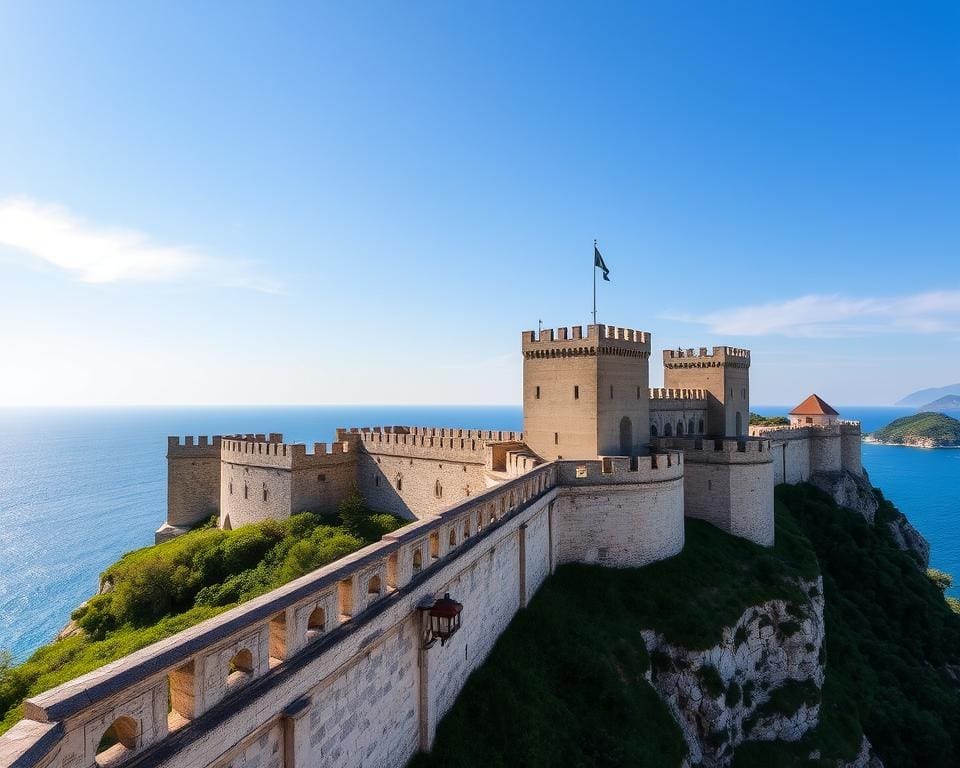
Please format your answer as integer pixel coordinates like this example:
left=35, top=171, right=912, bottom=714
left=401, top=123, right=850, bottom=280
left=0, top=325, right=862, bottom=768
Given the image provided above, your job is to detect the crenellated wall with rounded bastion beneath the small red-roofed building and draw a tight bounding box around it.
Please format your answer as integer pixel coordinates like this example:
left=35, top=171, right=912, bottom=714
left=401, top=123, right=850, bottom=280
left=750, top=421, right=863, bottom=484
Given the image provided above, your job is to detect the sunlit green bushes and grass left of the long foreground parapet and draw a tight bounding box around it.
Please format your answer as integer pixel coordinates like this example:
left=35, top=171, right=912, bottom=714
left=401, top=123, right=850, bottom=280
left=0, top=491, right=406, bottom=733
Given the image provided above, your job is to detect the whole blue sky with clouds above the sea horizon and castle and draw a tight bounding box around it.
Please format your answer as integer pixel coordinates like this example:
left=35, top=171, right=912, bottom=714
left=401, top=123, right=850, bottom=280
left=0, top=2, right=960, bottom=405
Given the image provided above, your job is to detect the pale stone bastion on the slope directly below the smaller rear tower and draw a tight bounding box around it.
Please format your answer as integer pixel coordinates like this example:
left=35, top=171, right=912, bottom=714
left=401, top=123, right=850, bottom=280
left=654, top=437, right=775, bottom=547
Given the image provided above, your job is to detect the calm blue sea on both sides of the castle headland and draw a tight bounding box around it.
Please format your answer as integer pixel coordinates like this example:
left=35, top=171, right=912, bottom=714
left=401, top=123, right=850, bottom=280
left=0, top=406, right=960, bottom=660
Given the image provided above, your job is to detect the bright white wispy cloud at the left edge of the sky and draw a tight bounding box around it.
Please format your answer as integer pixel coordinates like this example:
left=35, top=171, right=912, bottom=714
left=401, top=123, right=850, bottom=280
left=0, top=197, right=279, bottom=292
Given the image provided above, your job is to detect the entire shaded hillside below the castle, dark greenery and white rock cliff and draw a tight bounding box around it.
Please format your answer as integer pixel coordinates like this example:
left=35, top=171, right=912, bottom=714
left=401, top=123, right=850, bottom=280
left=412, top=486, right=960, bottom=768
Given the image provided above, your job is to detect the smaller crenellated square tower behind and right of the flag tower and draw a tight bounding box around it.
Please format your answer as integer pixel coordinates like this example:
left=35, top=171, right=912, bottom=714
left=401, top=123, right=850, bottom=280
left=663, top=347, right=750, bottom=437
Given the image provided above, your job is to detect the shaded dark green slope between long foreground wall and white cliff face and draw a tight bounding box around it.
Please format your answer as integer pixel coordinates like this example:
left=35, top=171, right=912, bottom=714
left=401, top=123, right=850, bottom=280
left=412, top=514, right=818, bottom=768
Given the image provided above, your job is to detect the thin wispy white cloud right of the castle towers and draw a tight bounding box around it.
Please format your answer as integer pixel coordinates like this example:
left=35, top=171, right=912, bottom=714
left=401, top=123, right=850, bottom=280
left=667, top=290, right=960, bottom=338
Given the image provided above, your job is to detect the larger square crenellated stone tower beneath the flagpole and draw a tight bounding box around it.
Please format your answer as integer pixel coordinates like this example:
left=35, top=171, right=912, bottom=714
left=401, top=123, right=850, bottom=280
left=523, top=325, right=650, bottom=460
